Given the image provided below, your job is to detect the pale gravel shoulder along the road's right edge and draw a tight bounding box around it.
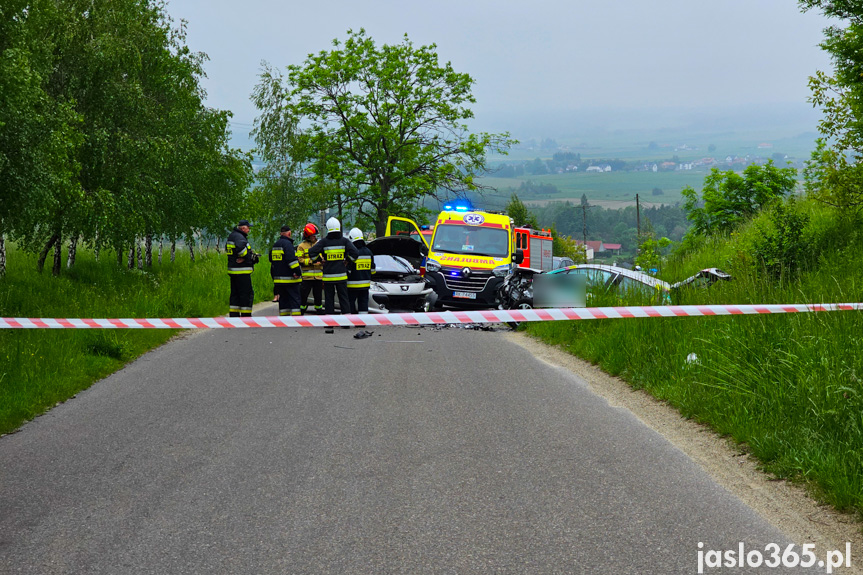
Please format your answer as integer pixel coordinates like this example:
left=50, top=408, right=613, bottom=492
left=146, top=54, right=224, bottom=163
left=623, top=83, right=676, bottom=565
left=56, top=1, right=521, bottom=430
left=503, top=332, right=863, bottom=574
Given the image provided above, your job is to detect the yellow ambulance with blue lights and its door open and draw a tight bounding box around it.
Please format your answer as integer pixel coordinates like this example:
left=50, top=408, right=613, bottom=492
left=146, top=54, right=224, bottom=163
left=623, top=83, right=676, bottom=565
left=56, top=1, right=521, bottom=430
left=386, top=203, right=523, bottom=309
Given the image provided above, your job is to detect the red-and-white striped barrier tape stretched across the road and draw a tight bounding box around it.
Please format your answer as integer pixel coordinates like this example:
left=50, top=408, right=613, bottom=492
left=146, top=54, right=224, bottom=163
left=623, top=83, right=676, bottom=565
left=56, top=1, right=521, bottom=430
left=0, top=303, right=863, bottom=329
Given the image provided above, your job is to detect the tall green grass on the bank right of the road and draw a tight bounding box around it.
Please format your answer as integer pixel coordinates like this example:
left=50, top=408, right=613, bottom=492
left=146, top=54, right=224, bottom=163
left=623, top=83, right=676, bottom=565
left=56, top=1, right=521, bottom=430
left=528, top=203, right=863, bottom=512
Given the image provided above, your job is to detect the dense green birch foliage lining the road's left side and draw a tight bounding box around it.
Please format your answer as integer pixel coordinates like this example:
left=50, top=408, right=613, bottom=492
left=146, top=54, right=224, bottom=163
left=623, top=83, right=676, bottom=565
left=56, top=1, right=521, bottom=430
left=0, top=0, right=251, bottom=274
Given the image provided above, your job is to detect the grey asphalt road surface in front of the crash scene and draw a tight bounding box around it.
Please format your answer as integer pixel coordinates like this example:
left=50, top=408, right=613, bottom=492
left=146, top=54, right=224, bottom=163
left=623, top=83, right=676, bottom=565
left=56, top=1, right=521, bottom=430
left=0, top=312, right=820, bottom=575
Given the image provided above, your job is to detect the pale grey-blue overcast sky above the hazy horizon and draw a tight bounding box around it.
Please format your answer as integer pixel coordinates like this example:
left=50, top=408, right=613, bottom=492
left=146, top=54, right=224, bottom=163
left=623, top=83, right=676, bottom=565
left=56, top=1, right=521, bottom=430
left=168, top=0, right=836, bottom=133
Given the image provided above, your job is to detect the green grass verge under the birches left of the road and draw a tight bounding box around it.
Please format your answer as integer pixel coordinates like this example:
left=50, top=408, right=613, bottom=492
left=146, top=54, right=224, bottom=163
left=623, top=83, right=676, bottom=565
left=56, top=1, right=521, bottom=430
left=0, top=244, right=272, bottom=434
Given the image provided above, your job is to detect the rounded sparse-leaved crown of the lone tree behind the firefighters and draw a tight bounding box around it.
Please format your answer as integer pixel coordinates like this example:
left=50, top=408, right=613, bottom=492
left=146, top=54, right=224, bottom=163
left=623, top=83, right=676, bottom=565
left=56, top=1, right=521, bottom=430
left=253, top=29, right=514, bottom=234
